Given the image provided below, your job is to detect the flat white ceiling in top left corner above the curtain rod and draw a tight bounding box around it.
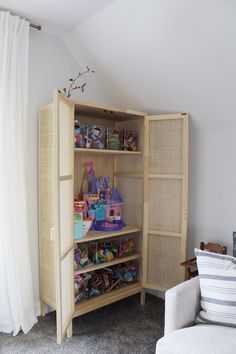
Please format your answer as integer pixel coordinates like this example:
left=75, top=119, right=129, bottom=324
left=0, top=0, right=115, bottom=37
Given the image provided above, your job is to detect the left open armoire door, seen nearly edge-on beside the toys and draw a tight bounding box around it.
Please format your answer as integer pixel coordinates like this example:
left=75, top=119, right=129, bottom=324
left=54, top=92, right=74, bottom=343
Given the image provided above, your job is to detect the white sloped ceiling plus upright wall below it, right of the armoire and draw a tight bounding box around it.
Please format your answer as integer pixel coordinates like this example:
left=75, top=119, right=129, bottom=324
left=64, top=0, right=236, bottom=256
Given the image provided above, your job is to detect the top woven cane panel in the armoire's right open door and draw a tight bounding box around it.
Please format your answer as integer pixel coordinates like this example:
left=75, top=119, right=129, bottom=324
left=149, top=119, right=183, bottom=174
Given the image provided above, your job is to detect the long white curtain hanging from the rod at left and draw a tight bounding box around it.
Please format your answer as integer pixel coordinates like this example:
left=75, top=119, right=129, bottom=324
left=0, top=11, right=37, bottom=335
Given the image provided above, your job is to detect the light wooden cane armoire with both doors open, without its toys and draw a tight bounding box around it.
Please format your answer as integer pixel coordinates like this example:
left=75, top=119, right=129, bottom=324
left=39, top=90, right=188, bottom=343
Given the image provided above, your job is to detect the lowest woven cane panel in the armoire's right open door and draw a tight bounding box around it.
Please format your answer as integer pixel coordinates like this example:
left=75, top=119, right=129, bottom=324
left=147, top=234, right=181, bottom=288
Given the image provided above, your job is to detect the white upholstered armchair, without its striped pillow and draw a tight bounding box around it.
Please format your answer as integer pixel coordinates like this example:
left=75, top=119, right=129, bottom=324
left=156, top=277, right=236, bottom=354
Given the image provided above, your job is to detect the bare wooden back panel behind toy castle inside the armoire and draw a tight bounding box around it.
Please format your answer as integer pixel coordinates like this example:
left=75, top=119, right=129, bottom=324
left=74, top=152, right=114, bottom=198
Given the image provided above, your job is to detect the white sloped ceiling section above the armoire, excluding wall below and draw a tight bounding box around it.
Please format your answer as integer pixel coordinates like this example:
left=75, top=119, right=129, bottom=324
left=64, top=0, right=236, bottom=129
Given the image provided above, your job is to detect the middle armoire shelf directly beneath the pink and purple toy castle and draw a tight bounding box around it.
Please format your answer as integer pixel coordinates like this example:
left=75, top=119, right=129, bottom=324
left=74, top=226, right=141, bottom=244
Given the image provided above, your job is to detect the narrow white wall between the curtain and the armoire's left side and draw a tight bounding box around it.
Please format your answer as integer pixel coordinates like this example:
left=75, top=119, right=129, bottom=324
left=27, top=30, right=84, bottom=313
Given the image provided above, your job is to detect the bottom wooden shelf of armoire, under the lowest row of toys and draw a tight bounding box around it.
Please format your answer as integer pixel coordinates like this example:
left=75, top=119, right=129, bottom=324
left=73, top=282, right=142, bottom=317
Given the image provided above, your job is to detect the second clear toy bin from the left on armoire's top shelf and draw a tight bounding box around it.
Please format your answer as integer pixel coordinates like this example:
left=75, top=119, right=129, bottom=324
left=86, top=125, right=106, bottom=149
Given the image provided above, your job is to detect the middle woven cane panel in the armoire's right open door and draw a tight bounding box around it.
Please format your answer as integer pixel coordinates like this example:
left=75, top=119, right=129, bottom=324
left=148, top=179, right=182, bottom=232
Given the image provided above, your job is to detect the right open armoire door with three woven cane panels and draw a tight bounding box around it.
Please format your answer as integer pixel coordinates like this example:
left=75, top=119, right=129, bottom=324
left=143, top=114, right=188, bottom=291
